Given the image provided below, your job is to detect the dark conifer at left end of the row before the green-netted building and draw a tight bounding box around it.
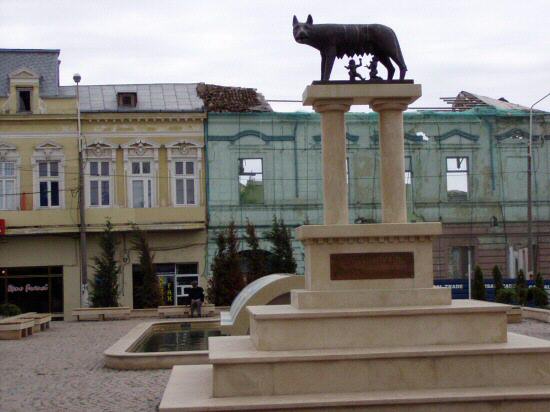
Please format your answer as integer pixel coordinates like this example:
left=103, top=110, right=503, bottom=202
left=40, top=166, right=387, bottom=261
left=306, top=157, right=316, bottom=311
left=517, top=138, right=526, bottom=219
left=207, top=222, right=244, bottom=306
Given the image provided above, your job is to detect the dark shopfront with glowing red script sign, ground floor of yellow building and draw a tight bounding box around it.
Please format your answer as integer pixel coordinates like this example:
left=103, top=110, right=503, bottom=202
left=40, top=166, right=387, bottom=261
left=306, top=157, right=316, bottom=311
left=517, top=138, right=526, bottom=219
left=0, top=266, right=63, bottom=315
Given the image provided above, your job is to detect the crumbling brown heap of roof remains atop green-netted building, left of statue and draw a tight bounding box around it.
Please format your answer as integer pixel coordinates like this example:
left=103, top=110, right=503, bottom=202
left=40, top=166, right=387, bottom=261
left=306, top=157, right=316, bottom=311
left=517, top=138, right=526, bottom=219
left=197, top=83, right=273, bottom=112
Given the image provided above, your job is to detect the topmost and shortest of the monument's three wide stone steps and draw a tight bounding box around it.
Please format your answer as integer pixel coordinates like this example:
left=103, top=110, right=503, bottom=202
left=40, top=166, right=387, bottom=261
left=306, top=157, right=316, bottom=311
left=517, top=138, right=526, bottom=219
left=248, top=300, right=509, bottom=351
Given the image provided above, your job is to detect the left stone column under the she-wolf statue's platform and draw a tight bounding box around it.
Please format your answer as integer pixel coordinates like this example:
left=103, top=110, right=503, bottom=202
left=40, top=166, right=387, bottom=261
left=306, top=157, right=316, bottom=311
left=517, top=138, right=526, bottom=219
left=313, top=99, right=351, bottom=225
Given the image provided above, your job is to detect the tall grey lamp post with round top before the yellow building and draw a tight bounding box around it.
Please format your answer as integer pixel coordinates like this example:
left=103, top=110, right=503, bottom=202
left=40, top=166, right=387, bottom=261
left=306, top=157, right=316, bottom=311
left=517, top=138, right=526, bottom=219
left=73, top=73, right=88, bottom=308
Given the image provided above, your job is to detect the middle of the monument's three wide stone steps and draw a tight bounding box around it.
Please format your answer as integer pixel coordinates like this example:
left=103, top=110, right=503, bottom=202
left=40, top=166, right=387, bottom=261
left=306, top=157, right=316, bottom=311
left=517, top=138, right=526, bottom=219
left=209, top=334, right=550, bottom=397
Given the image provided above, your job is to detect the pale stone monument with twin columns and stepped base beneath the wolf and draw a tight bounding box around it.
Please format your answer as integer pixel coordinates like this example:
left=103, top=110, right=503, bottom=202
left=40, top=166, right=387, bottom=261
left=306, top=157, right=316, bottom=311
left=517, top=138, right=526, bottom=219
left=160, top=16, right=550, bottom=412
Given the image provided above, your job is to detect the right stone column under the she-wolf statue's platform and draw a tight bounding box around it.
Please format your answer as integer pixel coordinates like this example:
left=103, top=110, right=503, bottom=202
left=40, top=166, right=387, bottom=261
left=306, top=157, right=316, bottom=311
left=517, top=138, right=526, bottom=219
left=370, top=98, right=410, bottom=223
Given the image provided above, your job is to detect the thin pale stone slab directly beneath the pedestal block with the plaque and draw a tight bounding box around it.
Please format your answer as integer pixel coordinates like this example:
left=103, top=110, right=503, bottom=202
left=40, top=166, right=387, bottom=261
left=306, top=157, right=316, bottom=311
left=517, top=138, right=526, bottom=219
left=290, top=288, right=451, bottom=309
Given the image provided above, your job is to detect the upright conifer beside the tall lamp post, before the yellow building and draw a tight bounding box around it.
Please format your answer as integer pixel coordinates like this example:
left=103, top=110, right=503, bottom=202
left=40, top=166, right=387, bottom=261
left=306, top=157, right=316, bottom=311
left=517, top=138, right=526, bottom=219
left=90, top=220, right=120, bottom=308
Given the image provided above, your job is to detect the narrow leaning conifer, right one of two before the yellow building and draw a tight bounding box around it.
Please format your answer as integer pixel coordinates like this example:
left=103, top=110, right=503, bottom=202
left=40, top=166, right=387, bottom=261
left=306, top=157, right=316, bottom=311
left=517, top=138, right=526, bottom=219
left=133, top=226, right=161, bottom=308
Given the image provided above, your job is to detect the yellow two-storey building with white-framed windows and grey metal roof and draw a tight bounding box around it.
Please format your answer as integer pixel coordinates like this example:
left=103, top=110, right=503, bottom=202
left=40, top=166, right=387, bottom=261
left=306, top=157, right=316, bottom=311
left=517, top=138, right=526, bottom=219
left=0, top=49, right=206, bottom=319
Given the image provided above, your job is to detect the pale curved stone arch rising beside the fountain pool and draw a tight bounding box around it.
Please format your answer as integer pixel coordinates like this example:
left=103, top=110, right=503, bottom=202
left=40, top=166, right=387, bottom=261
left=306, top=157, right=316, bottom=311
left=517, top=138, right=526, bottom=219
left=220, top=273, right=305, bottom=335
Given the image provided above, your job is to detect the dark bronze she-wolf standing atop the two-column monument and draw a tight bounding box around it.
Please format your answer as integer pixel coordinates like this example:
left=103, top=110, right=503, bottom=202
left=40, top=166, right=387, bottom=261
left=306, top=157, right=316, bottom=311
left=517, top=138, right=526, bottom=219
left=292, top=14, right=407, bottom=81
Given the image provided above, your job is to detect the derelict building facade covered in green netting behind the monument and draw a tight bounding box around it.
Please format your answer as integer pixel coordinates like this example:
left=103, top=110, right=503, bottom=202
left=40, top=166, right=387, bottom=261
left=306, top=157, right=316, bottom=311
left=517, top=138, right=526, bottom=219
left=206, top=107, right=550, bottom=279
